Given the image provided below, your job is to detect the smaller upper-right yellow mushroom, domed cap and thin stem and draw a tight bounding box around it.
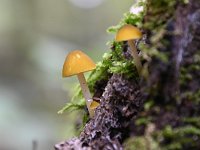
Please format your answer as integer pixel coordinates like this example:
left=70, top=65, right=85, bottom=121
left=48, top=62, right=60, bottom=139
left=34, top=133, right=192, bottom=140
left=115, top=24, right=142, bottom=75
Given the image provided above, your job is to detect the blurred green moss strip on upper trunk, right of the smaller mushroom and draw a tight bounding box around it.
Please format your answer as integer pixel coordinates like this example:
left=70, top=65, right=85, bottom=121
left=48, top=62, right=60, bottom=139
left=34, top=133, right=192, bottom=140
left=139, top=0, right=188, bottom=63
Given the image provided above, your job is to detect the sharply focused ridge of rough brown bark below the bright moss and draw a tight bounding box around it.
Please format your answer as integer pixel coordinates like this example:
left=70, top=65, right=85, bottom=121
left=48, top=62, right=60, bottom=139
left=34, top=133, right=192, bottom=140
left=55, top=74, right=143, bottom=150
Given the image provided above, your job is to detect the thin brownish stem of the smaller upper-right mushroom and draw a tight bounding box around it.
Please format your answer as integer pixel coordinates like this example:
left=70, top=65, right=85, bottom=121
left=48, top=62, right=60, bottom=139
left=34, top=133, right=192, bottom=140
left=128, top=40, right=142, bottom=75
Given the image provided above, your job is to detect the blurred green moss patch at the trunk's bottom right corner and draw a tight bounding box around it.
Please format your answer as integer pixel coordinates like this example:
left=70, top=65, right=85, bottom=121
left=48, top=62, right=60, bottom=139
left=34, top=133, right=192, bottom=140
left=124, top=125, right=200, bottom=150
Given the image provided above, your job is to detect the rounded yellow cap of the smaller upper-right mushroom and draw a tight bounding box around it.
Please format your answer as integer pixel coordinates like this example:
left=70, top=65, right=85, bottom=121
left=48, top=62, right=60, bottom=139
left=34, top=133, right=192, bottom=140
left=115, top=24, right=142, bottom=42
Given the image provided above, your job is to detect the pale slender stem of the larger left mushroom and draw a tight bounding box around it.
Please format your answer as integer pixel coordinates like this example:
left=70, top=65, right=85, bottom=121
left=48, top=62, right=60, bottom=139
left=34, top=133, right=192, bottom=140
left=77, top=73, right=94, bottom=117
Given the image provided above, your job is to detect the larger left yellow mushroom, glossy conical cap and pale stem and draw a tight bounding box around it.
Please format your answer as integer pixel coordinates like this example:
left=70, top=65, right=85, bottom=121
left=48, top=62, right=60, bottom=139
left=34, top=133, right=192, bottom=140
left=62, top=50, right=96, bottom=117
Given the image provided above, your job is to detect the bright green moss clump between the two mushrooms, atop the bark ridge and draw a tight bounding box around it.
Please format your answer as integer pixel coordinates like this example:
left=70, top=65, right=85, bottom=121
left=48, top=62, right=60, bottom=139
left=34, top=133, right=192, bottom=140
left=88, top=41, right=138, bottom=91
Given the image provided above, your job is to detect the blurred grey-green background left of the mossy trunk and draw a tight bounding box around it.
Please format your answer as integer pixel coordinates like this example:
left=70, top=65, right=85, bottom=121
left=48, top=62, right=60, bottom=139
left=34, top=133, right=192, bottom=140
left=0, top=0, right=133, bottom=150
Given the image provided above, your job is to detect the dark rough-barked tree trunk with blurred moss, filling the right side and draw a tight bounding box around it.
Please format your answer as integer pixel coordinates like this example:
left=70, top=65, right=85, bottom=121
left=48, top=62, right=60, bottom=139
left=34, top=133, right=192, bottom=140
left=55, top=0, right=200, bottom=150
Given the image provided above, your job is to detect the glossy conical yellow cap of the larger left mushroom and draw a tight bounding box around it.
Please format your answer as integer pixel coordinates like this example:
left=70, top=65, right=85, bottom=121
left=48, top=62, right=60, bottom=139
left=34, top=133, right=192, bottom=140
left=62, top=50, right=96, bottom=77
